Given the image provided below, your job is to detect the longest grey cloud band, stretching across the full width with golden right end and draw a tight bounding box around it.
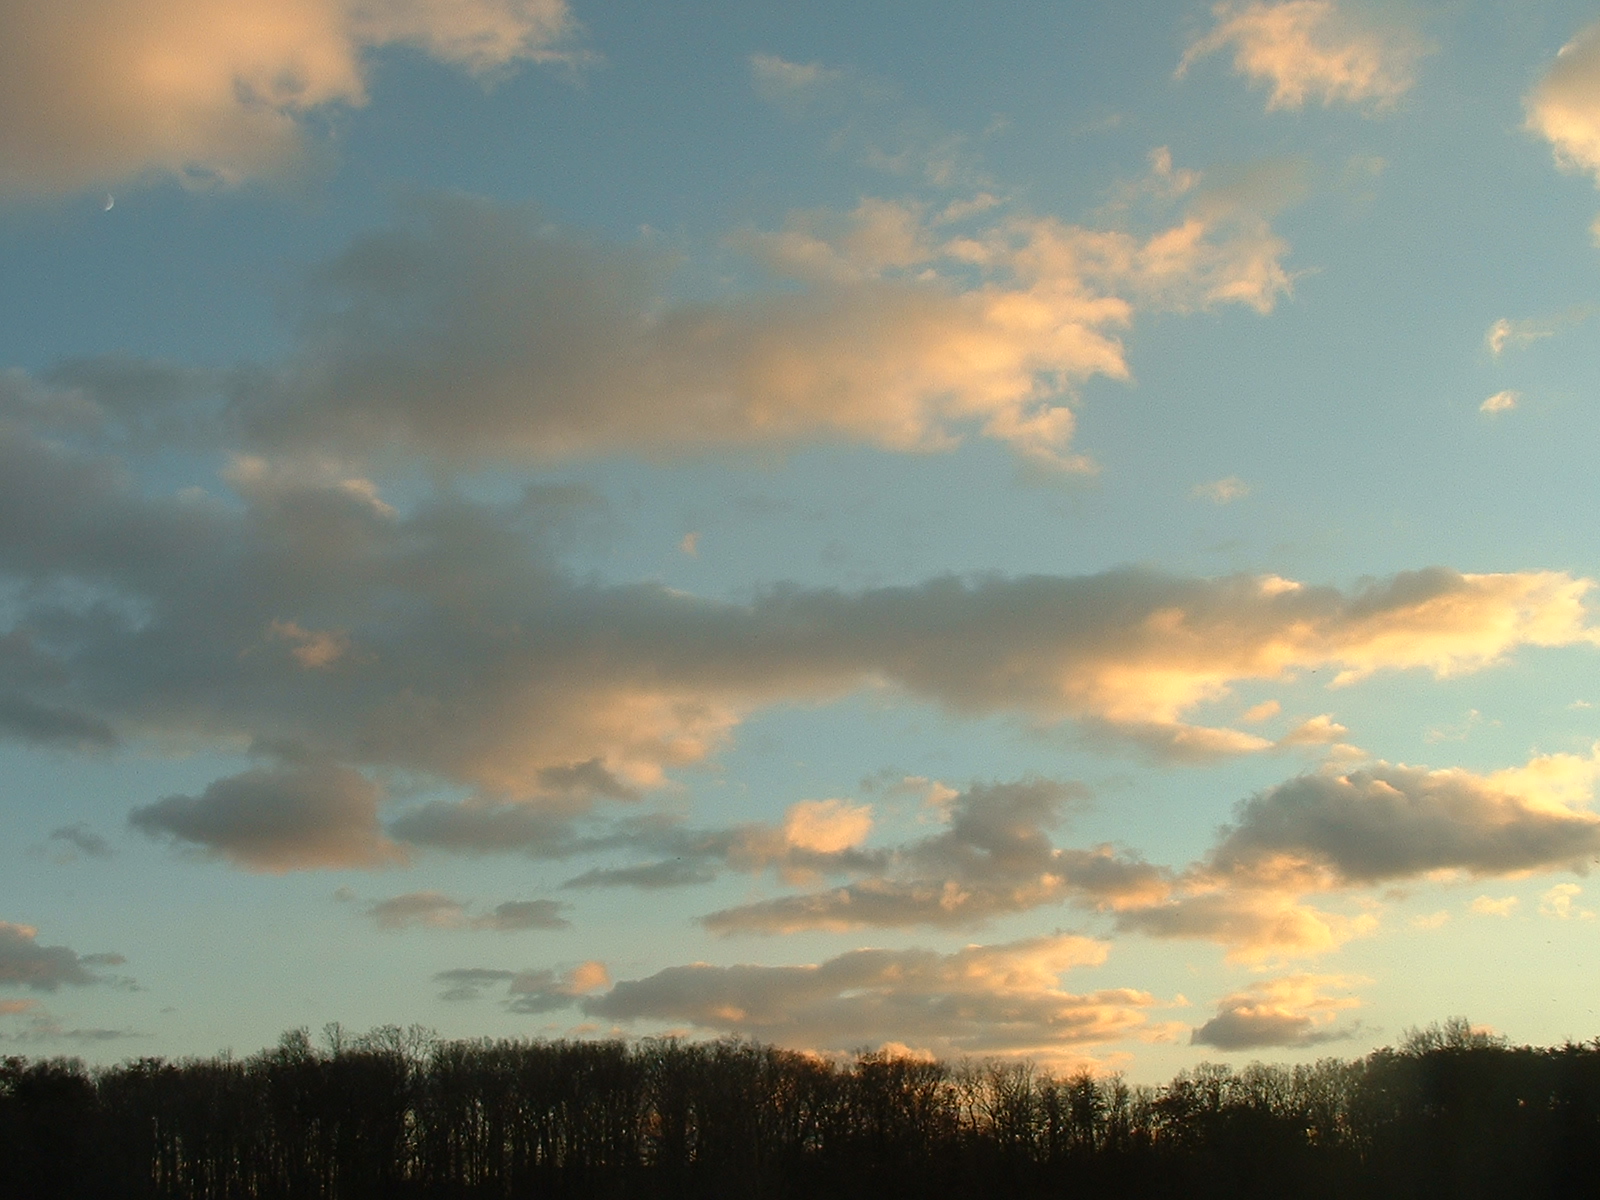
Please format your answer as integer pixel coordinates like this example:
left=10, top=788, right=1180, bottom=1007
left=0, top=400, right=1595, bottom=870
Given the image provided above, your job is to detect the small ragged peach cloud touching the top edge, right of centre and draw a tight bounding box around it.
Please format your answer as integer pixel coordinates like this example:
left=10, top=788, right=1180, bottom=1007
left=1178, top=0, right=1422, bottom=112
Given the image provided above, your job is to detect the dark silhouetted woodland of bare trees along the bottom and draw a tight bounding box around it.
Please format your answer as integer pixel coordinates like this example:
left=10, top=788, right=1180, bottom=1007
left=0, top=1021, right=1600, bottom=1200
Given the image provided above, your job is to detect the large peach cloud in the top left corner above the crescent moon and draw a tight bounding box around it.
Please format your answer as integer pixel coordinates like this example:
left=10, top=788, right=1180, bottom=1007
left=0, top=0, right=573, bottom=195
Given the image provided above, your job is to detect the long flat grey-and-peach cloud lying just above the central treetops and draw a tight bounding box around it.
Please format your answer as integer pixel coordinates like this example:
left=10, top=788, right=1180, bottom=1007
left=582, top=934, right=1155, bottom=1059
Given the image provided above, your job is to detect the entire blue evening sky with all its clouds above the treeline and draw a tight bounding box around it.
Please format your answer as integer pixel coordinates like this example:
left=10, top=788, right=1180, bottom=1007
left=0, top=0, right=1600, bottom=1082
